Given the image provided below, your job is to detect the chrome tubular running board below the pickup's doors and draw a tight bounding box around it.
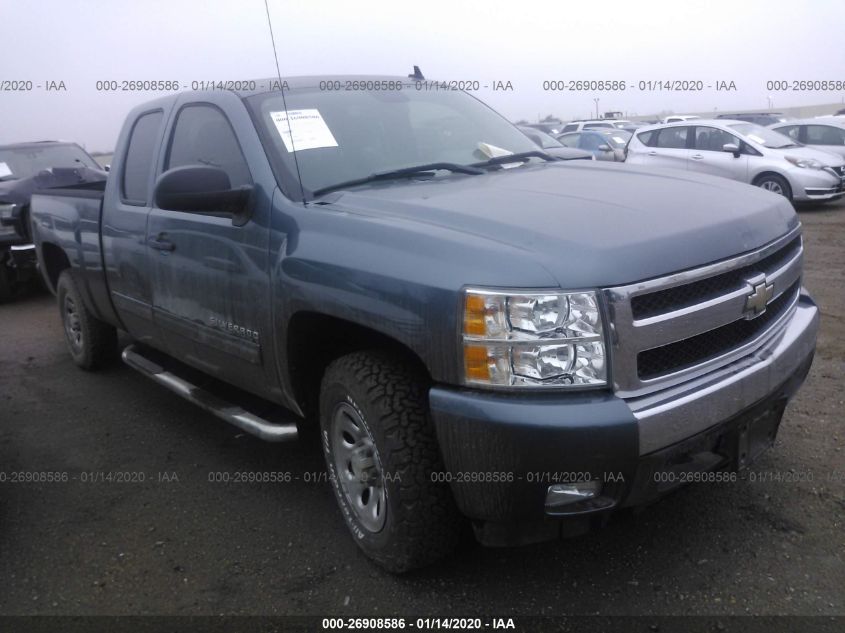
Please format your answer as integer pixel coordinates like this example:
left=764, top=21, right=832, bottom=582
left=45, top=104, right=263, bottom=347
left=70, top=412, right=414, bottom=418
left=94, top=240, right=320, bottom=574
left=121, top=345, right=297, bottom=442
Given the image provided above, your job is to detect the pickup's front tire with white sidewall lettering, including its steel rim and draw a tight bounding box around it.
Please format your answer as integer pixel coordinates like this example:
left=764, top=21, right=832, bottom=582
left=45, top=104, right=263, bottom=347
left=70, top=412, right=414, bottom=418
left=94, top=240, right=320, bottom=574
left=320, top=352, right=462, bottom=573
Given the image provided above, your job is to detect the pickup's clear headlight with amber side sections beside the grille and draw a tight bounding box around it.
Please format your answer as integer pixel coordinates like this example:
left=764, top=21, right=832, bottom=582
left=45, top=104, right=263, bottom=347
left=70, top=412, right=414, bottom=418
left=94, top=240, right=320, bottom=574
left=463, top=289, right=607, bottom=388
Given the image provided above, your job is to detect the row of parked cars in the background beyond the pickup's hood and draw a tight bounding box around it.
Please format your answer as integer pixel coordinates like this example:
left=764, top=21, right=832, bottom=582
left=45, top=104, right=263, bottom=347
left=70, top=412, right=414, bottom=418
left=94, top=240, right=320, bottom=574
left=520, top=113, right=845, bottom=202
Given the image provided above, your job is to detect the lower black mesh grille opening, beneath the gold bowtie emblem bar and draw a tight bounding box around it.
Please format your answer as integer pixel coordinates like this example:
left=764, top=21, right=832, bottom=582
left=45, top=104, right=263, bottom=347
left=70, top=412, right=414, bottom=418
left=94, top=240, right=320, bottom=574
left=637, top=282, right=800, bottom=380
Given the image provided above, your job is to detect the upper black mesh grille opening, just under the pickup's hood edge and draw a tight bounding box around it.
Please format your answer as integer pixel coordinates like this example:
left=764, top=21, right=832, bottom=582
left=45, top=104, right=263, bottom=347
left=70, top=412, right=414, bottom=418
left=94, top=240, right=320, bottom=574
left=631, top=236, right=801, bottom=319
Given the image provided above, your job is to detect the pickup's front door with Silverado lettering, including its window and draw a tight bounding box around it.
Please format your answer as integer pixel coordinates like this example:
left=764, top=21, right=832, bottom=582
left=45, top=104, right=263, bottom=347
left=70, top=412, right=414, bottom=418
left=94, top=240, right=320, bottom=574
left=147, top=103, right=270, bottom=393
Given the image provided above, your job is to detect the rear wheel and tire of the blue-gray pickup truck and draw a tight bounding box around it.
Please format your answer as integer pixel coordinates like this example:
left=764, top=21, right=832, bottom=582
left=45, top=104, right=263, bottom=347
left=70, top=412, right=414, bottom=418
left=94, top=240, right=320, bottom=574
left=56, top=270, right=117, bottom=371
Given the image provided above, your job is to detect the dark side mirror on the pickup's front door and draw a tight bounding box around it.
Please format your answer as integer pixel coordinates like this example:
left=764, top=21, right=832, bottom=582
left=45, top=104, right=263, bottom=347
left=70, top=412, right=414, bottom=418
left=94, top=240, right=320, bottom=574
left=153, top=165, right=252, bottom=226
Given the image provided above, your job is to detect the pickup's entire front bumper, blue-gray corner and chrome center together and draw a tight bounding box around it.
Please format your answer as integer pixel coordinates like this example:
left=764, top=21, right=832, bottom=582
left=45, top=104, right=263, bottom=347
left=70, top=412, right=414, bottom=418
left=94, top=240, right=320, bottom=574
left=429, top=293, right=819, bottom=544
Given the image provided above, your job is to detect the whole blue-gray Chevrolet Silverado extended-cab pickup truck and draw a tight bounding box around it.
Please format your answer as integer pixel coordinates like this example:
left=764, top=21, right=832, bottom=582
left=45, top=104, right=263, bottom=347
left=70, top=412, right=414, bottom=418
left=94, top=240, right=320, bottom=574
left=31, top=77, right=818, bottom=572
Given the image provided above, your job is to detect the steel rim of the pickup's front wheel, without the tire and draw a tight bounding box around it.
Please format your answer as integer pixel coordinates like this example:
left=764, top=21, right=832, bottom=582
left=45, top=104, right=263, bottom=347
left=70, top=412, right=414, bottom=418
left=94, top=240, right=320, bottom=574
left=331, top=402, right=387, bottom=533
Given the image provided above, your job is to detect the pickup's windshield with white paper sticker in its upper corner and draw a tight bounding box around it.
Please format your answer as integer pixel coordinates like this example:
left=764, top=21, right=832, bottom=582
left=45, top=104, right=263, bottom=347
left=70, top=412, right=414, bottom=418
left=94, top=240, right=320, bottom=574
left=249, top=82, right=537, bottom=192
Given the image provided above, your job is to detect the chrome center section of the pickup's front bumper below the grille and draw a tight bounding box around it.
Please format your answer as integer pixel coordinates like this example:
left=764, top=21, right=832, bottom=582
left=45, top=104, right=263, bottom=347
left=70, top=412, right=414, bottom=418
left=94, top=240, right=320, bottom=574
left=627, top=289, right=819, bottom=455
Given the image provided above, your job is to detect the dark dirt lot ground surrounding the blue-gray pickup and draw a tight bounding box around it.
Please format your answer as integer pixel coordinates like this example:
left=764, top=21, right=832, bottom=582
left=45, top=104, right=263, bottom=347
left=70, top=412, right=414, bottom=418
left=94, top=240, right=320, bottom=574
left=0, top=202, right=845, bottom=616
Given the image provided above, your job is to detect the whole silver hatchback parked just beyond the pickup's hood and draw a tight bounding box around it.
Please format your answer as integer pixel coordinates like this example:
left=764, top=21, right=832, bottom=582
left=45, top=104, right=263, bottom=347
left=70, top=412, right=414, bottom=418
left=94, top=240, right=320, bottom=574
left=627, top=119, right=845, bottom=201
